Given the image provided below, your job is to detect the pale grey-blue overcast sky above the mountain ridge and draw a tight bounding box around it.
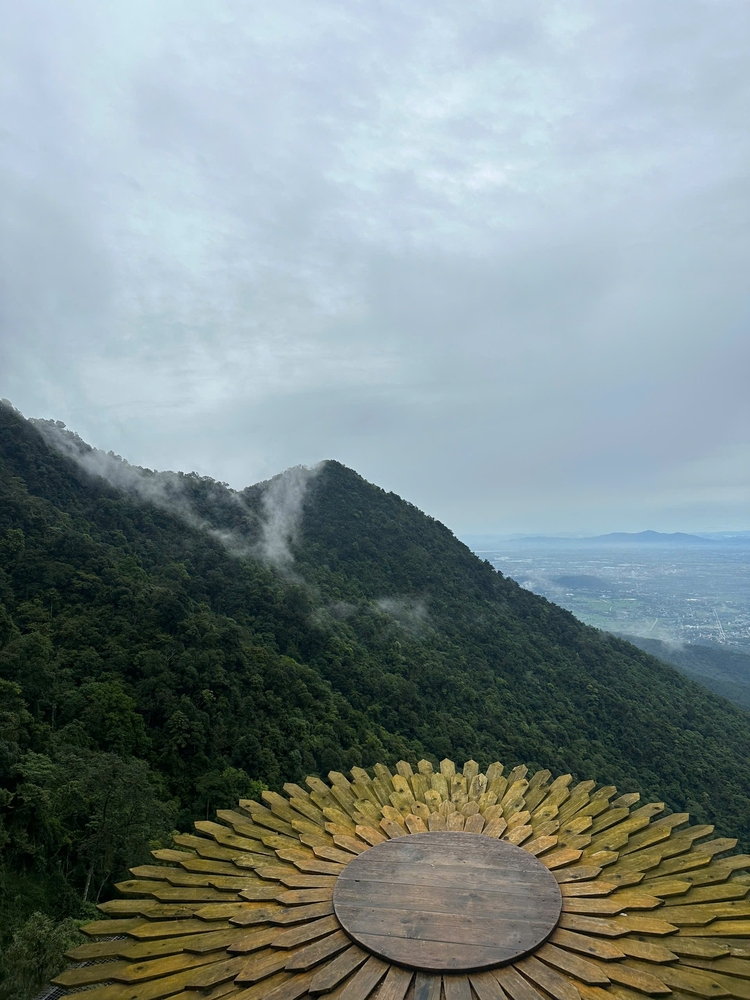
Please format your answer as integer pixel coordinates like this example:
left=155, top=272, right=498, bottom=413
left=0, top=0, right=750, bottom=533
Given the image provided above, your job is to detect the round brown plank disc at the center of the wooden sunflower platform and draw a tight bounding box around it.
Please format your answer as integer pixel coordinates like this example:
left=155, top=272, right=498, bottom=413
left=333, top=831, right=562, bottom=972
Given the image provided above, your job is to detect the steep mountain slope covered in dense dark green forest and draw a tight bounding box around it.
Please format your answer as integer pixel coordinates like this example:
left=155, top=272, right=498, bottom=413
left=0, top=406, right=750, bottom=992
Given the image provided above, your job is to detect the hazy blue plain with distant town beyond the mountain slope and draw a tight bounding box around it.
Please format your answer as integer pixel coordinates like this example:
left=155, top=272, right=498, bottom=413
left=466, top=532, right=750, bottom=652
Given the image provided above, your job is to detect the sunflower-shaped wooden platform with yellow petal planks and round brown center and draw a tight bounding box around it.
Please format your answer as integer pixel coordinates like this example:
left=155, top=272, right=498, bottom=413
left=55, top=761, right=750, bottom=1000
